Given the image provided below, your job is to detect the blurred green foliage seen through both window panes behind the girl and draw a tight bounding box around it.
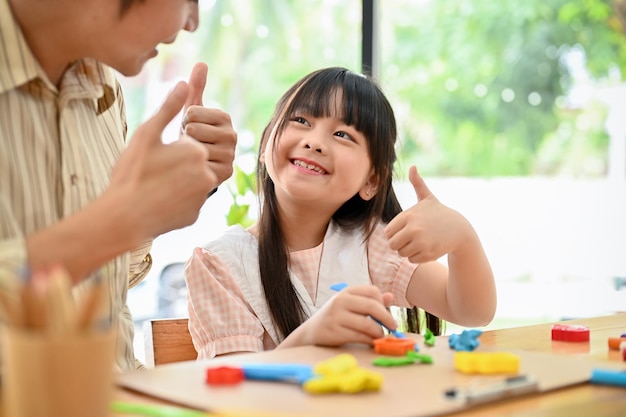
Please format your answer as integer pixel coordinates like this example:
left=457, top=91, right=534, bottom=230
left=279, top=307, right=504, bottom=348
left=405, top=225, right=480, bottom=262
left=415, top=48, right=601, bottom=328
left=119, top=0, right=626, bottom=224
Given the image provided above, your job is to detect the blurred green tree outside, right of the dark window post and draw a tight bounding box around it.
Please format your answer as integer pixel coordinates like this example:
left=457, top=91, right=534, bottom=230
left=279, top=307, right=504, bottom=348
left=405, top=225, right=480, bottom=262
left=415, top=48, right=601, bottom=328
left=381, top=0, right=626, bottom=176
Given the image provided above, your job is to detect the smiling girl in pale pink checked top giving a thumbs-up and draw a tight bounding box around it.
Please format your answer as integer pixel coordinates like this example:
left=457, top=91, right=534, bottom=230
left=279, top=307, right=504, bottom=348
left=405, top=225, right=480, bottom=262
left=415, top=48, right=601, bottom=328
left=185, top=68, right=496, bottom=358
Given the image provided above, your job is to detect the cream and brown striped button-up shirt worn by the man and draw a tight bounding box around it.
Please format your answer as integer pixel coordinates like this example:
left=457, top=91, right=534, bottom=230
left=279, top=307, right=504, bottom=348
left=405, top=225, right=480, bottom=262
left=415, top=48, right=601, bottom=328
left=0, top=0, right=151, bottom=370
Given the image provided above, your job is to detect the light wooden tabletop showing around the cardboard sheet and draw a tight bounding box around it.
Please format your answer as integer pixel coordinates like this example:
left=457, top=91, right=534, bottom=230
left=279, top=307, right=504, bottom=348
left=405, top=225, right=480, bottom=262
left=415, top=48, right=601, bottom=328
left=5, top=313, right=626, bottom=417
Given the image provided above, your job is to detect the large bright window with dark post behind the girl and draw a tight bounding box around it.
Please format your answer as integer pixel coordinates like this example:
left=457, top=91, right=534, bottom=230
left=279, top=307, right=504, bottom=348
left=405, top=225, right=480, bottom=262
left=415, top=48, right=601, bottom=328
left=124, top=0, right=626, bottom=360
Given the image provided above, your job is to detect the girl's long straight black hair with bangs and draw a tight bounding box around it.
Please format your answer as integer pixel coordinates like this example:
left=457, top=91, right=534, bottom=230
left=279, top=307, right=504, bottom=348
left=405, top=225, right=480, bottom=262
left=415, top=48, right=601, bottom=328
left=257, top=67, right=441, bottom=337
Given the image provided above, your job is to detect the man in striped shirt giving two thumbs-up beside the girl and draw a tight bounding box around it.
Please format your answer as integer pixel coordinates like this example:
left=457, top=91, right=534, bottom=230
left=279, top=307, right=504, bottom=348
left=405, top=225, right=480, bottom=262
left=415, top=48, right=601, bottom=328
left=0, top=0, right=236, bottom=370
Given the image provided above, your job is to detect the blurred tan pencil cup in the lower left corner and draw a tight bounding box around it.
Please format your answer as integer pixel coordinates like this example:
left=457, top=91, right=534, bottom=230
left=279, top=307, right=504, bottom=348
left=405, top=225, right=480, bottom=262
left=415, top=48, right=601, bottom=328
left=0, top=327, right=116, bottom=417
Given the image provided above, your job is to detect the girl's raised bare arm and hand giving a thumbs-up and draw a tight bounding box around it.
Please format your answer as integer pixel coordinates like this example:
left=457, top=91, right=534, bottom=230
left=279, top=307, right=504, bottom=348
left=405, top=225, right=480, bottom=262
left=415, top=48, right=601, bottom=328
left=385, top=167, right=496, bottom=327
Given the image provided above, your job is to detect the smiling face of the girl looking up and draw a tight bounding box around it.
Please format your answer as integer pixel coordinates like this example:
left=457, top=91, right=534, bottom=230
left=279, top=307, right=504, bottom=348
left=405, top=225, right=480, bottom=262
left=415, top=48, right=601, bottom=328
left=261, top=98, right=375, bottom=214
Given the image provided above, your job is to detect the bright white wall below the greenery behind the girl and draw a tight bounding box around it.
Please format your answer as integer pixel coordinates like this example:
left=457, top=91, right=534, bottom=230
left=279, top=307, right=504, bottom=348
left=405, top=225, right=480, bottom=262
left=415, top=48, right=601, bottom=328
left=131, top=178, right=626, bottom=320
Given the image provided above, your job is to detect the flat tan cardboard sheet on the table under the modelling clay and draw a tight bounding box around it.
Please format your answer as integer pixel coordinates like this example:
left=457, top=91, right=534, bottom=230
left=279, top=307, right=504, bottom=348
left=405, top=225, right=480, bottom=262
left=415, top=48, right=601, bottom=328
left=118, top=337, right=597, bottom=417
